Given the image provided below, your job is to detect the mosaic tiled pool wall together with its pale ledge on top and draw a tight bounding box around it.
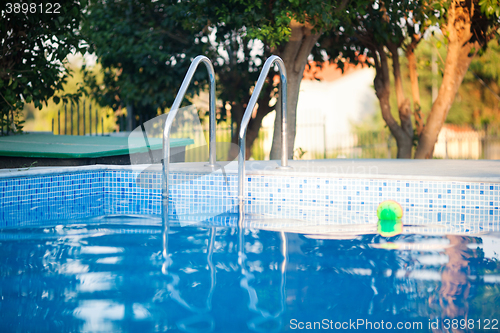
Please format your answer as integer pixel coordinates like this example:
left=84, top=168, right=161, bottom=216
left=0, top=160, right=500, bottom=228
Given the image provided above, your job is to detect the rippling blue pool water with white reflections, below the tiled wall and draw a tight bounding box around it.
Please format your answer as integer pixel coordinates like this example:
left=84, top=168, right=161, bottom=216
left=0, top=217, right=500, bottom=332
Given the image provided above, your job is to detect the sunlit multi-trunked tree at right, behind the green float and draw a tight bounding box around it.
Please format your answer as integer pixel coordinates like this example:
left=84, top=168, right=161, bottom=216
left=322, top=0, right=498, bottom=158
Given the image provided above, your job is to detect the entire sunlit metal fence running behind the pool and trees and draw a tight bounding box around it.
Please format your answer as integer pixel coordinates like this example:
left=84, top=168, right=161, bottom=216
left=48, top=102, right=500, bottom=162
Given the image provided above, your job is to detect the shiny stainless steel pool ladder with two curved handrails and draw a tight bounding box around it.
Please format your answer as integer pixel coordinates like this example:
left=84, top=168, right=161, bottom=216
left=162, top=55, right=291, bottom=217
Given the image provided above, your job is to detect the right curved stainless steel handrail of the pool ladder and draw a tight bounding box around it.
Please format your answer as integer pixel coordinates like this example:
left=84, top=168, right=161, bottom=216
left=238, top=55, right=291, bottom=209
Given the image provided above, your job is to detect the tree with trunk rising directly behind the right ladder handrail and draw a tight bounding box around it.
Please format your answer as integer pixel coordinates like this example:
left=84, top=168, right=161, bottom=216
left=215, top=0, right=348, bottom=159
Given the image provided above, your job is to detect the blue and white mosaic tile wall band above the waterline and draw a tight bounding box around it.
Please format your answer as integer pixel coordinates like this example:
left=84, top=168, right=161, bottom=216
left=0, top=170, right=500, bottom=231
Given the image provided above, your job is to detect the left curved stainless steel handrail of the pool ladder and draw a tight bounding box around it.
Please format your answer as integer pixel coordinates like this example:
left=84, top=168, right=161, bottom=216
left=162, top=55, right=217, bottom=216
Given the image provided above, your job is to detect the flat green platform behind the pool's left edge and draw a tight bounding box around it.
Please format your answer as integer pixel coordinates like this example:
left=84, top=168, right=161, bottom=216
left=0, top=133, right=194, bottom=168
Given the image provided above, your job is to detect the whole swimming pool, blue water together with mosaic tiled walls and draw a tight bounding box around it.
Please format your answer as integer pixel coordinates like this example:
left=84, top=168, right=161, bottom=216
left=0, top=161, right=500, bottom=332
